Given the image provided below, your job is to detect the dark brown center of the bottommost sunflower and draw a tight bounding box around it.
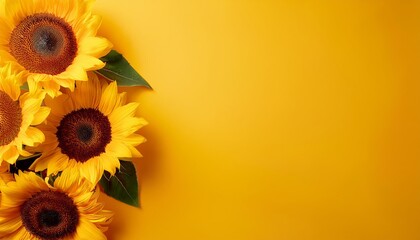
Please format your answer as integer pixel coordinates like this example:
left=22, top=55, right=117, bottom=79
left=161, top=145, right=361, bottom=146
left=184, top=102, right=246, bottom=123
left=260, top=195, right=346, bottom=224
left=20, top=191, right=79, bottom=239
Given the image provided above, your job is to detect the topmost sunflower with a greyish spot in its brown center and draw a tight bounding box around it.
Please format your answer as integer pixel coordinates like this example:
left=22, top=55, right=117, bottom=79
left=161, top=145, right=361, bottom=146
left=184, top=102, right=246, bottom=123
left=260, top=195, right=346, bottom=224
left=0, top=0, right=112, bottom=97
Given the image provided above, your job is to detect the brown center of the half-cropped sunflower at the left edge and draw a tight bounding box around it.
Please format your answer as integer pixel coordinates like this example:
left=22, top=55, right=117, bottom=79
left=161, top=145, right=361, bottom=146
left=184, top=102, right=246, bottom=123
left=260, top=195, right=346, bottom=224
left=0, top=91, right=22, bottom=146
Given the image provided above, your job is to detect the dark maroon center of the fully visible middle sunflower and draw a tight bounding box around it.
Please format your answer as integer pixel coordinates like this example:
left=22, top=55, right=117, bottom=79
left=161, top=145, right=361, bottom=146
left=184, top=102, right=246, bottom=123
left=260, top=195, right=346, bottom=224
left=56, top=108, right=111, bottom=162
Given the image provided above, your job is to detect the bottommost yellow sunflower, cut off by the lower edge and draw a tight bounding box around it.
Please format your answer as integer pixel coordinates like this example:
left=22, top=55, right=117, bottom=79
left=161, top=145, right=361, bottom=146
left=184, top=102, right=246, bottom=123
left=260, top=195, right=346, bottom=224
left=0, top=171, right=113, bottom=239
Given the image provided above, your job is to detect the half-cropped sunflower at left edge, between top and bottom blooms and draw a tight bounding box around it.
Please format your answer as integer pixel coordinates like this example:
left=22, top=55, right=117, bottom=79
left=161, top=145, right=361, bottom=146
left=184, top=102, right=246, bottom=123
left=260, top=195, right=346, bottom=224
left=0, top=64, right=50, bottom=164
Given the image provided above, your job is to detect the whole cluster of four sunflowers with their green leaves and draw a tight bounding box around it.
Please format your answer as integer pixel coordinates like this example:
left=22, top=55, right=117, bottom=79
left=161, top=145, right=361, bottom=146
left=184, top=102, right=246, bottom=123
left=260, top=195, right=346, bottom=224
left=0, top=0, right=150, bottom=239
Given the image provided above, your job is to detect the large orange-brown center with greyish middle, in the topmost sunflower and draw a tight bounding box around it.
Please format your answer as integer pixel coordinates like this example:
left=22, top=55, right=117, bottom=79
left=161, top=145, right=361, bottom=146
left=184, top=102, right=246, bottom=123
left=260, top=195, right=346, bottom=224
left=9, top=13, right=77, bottom=75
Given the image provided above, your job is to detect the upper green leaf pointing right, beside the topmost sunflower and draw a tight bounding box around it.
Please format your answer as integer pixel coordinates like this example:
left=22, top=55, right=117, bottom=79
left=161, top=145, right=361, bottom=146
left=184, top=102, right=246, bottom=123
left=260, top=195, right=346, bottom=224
left=96, top=50, right=152, bottom=89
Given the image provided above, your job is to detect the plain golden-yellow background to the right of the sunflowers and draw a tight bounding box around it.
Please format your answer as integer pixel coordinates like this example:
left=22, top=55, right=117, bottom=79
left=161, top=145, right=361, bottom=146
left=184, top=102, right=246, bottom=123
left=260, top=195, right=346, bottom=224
left=95, top=0, right=420, bottom=240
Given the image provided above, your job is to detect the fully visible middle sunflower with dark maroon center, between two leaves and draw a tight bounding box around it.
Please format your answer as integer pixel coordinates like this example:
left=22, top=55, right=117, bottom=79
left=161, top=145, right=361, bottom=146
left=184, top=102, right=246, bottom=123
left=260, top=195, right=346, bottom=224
left=31, top=73, right=147, bottom=184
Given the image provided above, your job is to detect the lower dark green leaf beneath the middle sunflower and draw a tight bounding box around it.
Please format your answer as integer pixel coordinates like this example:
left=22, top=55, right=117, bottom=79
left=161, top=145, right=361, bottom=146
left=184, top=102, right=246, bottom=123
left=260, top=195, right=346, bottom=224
left=99, top=160, right=140, bottom=207
